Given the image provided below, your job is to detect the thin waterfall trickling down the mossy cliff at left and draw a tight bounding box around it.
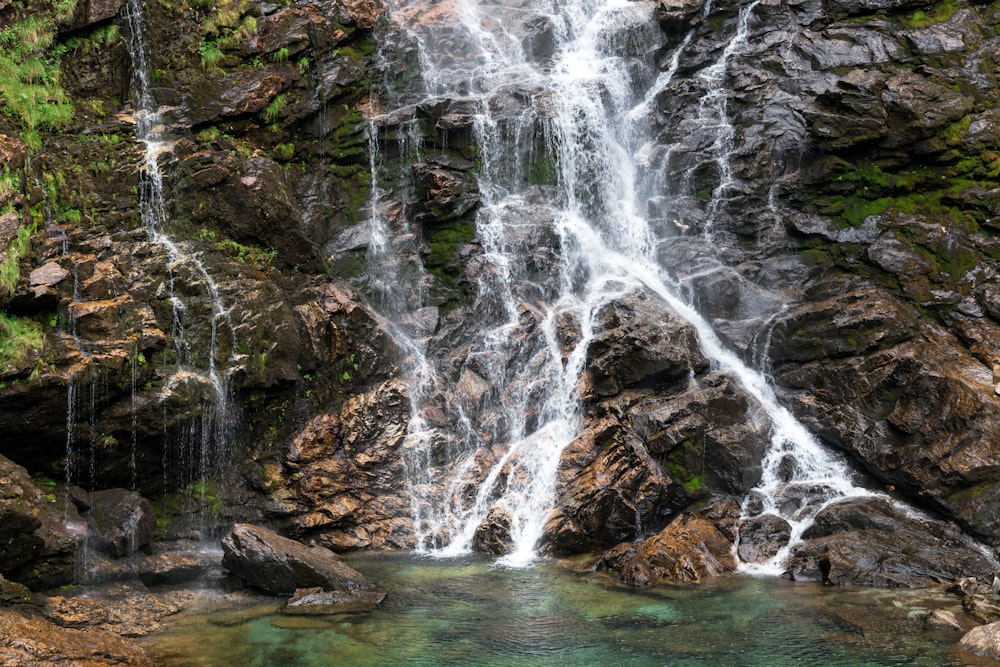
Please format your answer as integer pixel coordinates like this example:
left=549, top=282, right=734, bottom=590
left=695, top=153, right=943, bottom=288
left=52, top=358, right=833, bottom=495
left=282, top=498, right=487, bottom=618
left=123, top=0, right=237, bottom=516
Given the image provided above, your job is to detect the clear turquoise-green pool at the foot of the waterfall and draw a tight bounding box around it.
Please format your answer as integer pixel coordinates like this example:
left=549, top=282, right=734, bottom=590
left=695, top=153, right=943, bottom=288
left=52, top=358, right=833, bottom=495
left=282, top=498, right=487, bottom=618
left=145, top=555, right=980, bottom=667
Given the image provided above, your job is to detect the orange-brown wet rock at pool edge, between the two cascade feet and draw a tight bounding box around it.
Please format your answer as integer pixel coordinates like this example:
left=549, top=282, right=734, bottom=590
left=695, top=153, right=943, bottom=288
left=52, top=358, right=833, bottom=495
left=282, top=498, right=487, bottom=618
left=596, top=506, right=736, bottom=586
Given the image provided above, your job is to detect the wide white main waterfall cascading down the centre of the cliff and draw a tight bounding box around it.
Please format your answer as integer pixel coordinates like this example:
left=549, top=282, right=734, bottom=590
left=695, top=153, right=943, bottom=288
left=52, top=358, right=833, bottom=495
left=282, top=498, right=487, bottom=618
left=373, top=0, right=869, bottom=567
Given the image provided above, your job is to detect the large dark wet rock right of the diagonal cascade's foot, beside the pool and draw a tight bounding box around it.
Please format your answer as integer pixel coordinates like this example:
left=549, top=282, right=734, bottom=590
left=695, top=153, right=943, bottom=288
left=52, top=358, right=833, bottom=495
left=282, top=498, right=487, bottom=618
left=785, top=498, right=996, bottom=587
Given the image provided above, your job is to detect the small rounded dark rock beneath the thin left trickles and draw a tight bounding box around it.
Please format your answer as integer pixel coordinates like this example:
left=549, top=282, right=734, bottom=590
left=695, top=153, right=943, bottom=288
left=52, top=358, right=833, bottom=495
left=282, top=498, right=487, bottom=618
left=86, top=489, right=156, bottom=558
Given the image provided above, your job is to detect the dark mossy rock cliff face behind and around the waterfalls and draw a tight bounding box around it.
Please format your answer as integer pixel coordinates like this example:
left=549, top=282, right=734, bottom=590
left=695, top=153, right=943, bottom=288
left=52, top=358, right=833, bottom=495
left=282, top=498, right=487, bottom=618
left=0, top=0, right=1000, bottom=604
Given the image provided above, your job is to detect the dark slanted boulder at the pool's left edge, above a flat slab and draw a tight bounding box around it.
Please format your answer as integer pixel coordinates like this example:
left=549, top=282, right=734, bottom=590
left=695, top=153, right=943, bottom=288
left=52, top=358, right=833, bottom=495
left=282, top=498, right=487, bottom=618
left=222, top=523, right=374, bottom=595
